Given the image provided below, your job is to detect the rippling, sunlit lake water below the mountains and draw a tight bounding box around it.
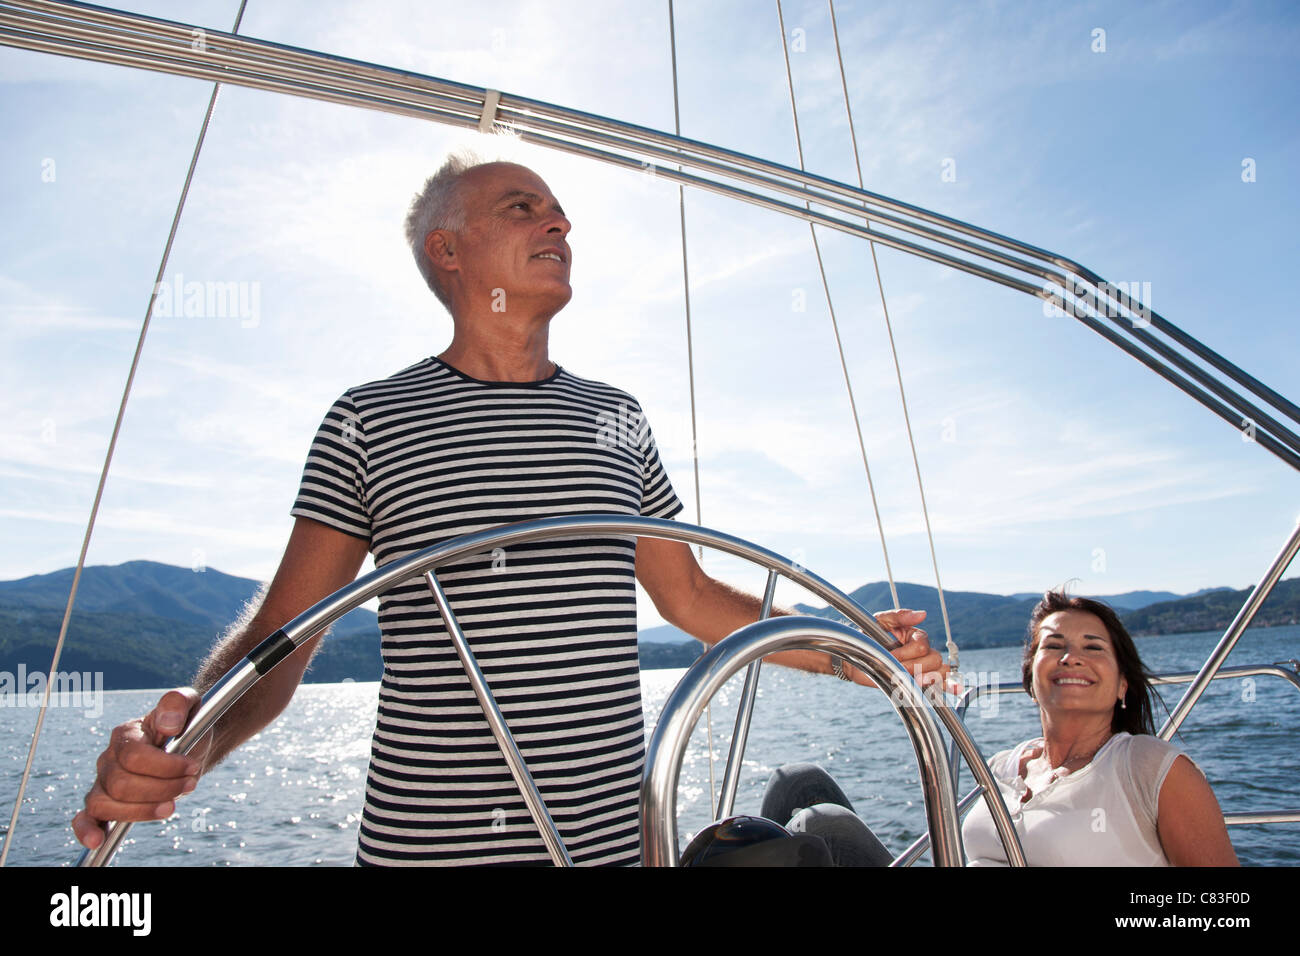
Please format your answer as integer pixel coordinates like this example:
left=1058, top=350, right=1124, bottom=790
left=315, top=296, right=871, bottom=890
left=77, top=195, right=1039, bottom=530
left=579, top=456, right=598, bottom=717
left=0, top=626, right=1300, bottom=866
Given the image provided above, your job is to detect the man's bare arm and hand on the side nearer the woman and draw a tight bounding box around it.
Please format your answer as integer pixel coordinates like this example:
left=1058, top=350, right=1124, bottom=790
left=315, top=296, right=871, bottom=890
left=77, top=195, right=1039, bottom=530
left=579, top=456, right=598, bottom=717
left=637, top=537, right=948, bottom=687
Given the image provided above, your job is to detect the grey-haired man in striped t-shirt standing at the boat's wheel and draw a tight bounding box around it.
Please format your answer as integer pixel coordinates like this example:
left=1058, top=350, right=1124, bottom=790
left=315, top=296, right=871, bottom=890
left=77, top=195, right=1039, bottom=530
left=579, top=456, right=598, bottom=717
left=73, top=159, right=944, bottom=865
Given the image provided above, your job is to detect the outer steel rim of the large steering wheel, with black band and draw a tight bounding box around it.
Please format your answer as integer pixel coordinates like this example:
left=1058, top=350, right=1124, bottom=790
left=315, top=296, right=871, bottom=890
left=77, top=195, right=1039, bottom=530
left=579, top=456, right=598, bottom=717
left=78, top=515, right=1023, bottom=866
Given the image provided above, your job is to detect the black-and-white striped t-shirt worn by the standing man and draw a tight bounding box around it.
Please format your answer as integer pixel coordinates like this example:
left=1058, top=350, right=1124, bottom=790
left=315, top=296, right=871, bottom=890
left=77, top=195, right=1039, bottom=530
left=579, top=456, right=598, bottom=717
left=293, top=358, right=681, bottom=865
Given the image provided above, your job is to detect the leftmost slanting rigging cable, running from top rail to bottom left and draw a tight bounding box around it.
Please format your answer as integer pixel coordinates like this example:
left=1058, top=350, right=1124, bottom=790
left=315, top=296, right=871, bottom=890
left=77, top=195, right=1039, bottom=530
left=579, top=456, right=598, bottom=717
left=0, top=0, right=248, bottom=866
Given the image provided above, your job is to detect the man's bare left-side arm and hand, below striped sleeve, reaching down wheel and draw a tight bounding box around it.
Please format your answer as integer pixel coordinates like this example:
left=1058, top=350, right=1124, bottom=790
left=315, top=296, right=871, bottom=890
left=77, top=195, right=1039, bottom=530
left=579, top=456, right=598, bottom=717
left=73, top=518, right=368, bottom=848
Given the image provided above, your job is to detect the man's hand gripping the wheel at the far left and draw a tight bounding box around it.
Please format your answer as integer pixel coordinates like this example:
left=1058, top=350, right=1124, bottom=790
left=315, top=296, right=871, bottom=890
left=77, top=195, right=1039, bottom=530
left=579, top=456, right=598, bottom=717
left=73, top=687, right=211, bottom=849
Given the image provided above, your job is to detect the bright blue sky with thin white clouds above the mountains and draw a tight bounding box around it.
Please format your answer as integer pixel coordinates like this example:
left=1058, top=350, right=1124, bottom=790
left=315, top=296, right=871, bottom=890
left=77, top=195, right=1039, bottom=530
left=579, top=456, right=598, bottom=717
left=0, top=0, right=1300, bottom=627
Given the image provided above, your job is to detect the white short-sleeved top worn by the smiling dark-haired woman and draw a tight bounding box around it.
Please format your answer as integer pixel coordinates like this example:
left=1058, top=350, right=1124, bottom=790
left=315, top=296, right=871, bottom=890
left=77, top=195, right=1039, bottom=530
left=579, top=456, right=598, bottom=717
left=962, top=732, right=1182, bottom=866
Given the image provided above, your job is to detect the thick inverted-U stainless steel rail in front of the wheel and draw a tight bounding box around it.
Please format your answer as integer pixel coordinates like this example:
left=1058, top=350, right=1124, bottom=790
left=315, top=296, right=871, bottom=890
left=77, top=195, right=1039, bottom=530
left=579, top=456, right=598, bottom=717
left=641, top=617, right=965, bottom=866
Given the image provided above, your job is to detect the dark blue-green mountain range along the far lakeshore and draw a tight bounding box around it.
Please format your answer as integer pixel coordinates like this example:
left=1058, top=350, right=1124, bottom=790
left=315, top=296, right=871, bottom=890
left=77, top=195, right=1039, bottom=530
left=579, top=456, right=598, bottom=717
left=0, top=561, right=1300, bottom=689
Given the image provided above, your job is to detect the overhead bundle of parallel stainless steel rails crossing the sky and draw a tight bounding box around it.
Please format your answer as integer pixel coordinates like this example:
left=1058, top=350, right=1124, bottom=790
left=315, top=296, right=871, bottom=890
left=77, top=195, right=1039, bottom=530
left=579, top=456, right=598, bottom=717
left=0, top=0, right=1300, bottom=470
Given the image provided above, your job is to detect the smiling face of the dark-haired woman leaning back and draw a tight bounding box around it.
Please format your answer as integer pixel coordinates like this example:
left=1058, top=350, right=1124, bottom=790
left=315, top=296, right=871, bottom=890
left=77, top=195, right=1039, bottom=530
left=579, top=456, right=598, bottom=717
left=1032, top=611, right=1128, bottom=719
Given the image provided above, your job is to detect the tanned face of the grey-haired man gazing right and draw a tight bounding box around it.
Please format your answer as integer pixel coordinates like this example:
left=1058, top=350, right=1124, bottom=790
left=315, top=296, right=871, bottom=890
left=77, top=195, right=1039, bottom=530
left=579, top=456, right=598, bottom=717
left=442, top=163, right=573, bottom=315
